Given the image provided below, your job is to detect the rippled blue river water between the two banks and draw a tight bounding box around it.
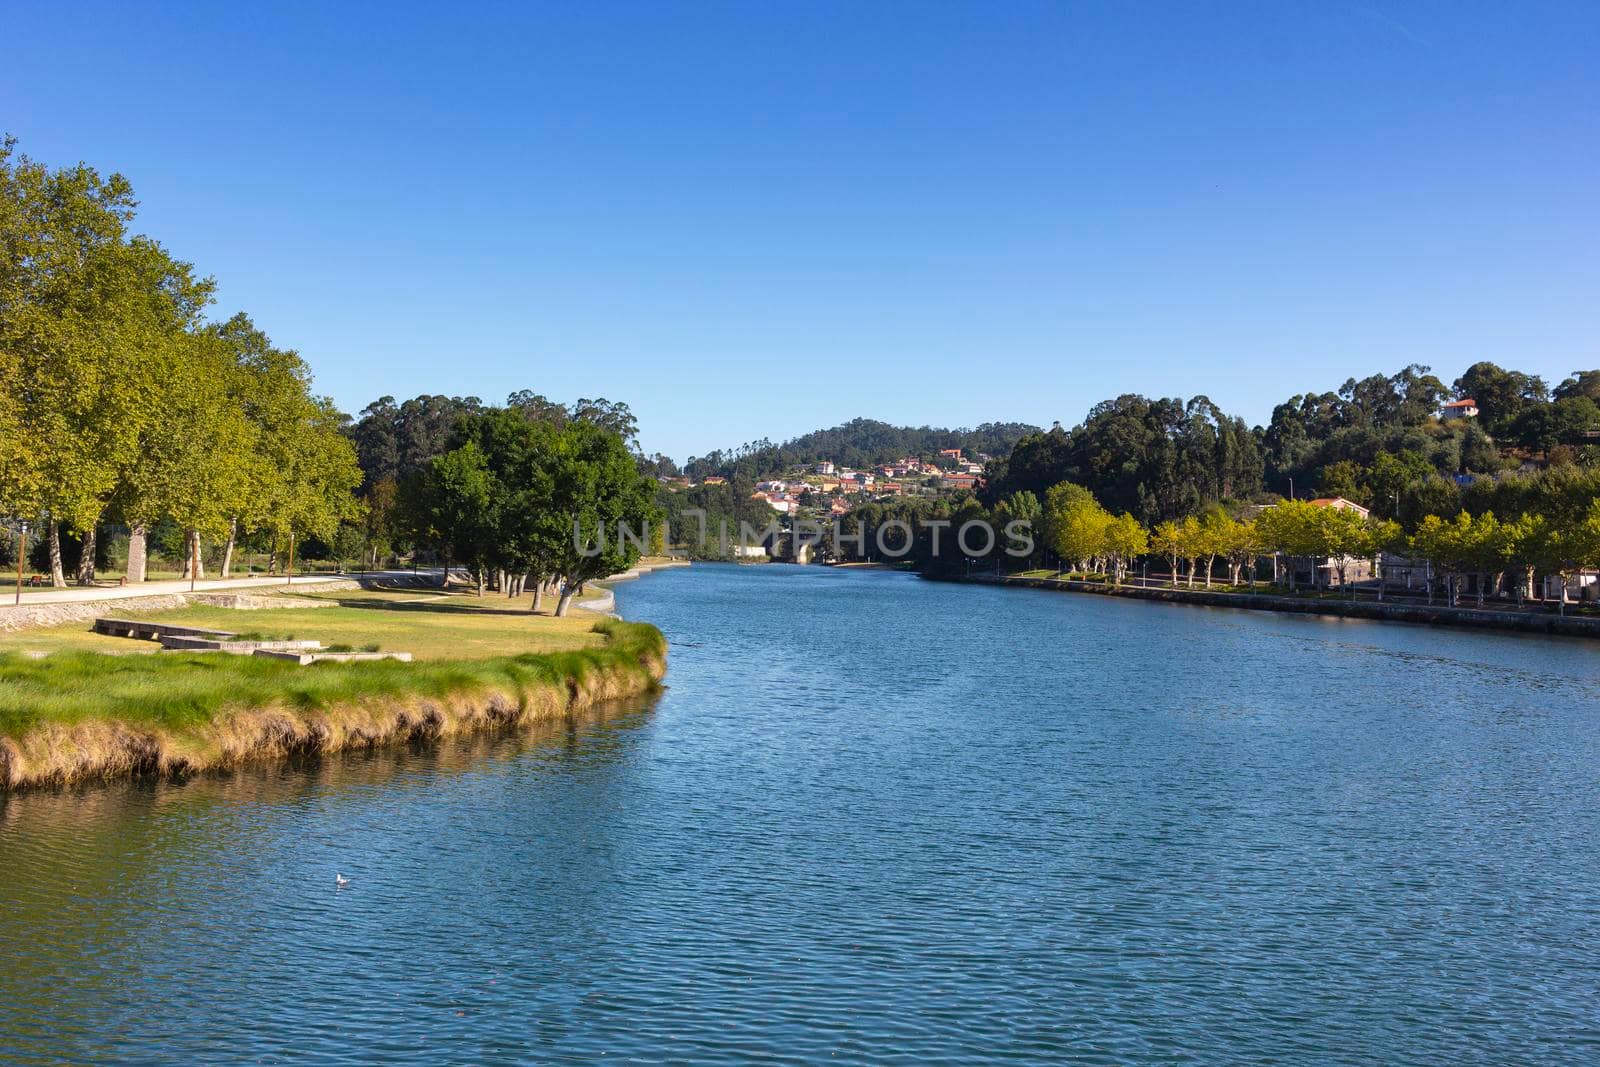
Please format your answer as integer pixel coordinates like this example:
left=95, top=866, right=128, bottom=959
left=0, top=566, right=1600, bottom=1064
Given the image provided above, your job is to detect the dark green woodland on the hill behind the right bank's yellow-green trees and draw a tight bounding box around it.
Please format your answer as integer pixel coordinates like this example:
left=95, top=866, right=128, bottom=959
left=984, top=362, right=1600, bottom=526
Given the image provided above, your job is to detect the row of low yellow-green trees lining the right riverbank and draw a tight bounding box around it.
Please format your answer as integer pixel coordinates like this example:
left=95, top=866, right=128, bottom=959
left=832, top=472, right=1600, bottom=609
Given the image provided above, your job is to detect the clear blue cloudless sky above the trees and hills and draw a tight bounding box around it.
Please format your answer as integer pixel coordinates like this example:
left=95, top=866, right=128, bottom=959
left=0, top=0, right=1600, bottom=459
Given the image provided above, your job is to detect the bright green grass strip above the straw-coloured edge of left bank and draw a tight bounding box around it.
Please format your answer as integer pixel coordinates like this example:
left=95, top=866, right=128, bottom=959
left=0, top=609, right=666, bottom=737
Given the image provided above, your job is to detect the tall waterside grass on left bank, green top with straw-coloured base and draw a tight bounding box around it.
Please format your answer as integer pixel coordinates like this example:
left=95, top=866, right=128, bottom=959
left=0, top=619, right=666, bottom=787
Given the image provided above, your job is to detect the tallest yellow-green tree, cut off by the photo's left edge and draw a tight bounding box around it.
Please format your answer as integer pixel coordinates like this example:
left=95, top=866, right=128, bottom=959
left=0, top=139, right=213, bottom=585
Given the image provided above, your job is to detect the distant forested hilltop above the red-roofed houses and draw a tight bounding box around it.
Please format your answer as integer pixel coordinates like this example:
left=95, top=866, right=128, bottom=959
left=683, top=419, right=1038, bottom=478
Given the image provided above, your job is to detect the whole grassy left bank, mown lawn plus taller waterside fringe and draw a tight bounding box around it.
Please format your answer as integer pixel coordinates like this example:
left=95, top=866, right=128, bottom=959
left=0, top=590, right=666, bottom=789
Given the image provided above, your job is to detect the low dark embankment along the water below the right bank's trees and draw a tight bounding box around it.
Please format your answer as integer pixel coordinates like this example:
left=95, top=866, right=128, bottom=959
left=936, top=574, right=1600, bottom=638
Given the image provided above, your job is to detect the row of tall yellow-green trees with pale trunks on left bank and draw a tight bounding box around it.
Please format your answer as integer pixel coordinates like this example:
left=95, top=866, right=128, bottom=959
left=0, top=139, right=360, bottom=585
